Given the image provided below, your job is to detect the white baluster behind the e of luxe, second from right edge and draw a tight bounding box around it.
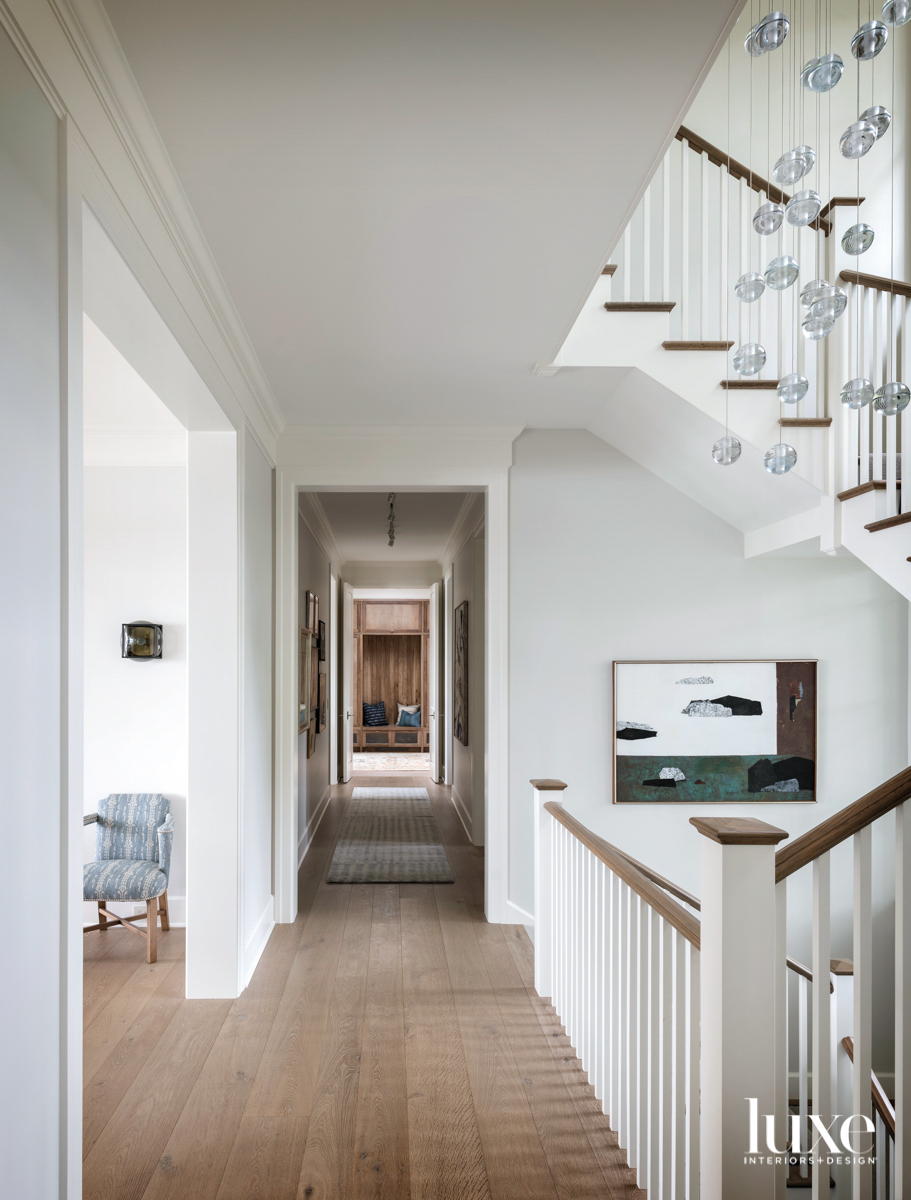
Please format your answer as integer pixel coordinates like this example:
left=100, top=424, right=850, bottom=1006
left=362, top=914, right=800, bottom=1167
left=851, top=826, right=873, bottom=1200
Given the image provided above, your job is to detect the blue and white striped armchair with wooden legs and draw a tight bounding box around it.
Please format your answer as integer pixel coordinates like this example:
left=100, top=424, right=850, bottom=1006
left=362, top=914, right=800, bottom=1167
left=83, top=792, right=174, bottom=962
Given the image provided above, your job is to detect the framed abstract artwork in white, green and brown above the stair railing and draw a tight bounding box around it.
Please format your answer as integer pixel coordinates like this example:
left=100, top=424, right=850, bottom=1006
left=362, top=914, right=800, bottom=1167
left=613, top=659, right=816, bottom=804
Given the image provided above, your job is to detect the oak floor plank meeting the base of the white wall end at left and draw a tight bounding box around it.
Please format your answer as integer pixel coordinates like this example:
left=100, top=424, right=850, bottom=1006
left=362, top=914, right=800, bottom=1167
left=83, top=1000, right=232, bottom=1200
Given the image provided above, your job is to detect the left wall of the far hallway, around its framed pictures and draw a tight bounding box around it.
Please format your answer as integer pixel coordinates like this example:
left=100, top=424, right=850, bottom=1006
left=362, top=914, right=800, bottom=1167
left=298, top=515, right=337, bottom=863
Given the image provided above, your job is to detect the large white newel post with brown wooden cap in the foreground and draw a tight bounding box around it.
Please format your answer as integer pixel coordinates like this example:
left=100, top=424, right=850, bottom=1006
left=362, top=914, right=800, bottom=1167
left=690, top=817, right=787, bottom=1200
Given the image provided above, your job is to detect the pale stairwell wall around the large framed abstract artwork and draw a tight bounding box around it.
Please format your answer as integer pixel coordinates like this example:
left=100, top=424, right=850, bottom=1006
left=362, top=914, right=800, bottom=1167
left=509, top=431, right=909, bottom=1052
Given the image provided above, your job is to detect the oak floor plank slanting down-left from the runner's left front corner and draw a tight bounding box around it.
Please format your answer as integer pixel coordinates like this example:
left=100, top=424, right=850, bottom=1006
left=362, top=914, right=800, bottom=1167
left=217, top=884, right=350, bottom=1200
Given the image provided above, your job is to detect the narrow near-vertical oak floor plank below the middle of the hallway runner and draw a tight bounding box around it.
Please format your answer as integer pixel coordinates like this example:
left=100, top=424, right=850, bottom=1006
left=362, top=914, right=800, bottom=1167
left=348, top=883, right=410, bottom=1200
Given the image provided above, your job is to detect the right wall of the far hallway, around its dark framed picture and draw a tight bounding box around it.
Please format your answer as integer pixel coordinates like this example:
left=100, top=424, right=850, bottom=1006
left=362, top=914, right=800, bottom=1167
left=446, top=530, right=486, bottom=846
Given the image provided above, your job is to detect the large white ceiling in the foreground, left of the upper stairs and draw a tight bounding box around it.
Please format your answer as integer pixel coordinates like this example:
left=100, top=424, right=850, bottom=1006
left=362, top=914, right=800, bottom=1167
left=106, top=0, right=733, bottom=427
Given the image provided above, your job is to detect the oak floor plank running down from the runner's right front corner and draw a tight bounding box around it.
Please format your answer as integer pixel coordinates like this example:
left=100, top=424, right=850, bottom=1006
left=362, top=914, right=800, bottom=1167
left=400, top=884, right=491, bottom=1200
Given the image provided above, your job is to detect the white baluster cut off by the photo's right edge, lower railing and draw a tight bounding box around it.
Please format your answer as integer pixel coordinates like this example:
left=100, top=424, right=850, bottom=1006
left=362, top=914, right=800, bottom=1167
left=893, top=800, right=911, bottom=1200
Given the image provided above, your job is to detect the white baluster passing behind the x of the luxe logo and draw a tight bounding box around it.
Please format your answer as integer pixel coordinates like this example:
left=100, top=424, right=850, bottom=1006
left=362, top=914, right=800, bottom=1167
left=816, top=854, right=832, bottom=1200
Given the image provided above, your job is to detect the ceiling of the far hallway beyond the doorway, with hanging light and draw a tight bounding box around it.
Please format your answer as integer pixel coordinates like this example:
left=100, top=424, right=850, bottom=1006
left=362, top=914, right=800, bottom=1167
left=317, top=491, right=467, bottom=563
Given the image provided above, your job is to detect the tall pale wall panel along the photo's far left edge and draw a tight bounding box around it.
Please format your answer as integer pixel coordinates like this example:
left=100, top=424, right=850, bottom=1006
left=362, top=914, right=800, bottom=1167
left=0, top=23, right=68, bottom=1200
